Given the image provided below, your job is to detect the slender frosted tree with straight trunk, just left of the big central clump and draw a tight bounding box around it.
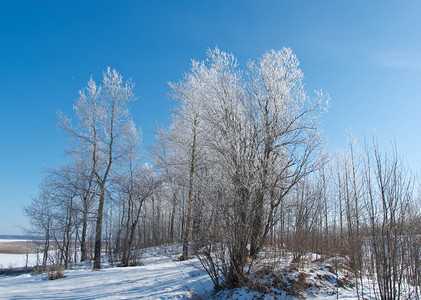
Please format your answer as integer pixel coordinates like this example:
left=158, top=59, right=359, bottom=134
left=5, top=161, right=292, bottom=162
left=166, top=61, right=215, bottom=260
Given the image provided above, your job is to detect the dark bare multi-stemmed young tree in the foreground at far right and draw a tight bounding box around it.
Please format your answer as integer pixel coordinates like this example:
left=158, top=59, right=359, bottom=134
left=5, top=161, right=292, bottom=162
left=364, top=140, right=420, bottom=299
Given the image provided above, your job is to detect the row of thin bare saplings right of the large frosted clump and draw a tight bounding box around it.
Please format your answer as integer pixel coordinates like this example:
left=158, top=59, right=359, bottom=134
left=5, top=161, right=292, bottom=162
left=272, top=138, right=421, bottom=299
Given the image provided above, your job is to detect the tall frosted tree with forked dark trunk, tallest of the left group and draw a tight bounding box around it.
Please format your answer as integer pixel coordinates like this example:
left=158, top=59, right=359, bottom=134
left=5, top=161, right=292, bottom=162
left=59, top=68, right=136, bottom=269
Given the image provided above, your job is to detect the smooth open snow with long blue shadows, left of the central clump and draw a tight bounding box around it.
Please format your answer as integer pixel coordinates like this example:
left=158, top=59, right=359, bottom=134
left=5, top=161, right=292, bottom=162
left=0, top=247, right=212, bottom=299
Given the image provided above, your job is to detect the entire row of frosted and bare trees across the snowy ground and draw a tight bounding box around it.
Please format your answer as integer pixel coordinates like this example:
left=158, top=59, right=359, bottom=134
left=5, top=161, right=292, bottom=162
left=25, top=48, right=421, bottom=299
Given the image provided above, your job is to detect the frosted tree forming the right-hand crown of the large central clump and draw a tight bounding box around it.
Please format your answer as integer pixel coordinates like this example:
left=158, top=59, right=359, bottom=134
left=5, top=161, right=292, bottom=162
left=247, top=48, right=329, bottom=256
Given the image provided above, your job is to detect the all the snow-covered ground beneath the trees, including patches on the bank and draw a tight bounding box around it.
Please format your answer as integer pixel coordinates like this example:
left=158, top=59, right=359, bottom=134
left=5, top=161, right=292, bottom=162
left=0, top=245, right=404, bottom=300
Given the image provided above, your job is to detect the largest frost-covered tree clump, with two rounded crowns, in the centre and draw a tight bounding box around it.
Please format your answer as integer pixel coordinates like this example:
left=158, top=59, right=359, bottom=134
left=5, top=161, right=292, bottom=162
left=163, top=48, right=328, bottom=286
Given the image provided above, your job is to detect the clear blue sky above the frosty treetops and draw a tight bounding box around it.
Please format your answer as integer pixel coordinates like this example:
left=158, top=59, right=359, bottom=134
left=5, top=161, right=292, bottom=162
left=0, top=0, right=421, bottom=234
